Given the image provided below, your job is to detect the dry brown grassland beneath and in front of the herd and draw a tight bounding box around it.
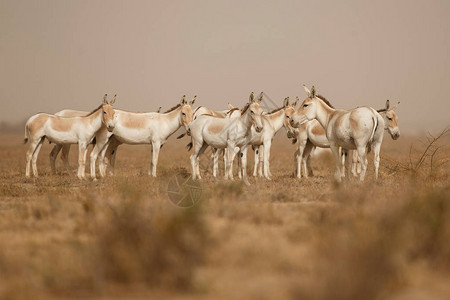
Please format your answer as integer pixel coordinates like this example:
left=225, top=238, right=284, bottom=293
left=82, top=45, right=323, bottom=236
left=0, top=132, right=450, bottom=299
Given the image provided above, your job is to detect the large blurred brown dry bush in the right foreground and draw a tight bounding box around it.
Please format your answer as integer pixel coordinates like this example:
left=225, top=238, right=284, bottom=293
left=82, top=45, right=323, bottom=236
left=293, top=187, right=450, bottom=299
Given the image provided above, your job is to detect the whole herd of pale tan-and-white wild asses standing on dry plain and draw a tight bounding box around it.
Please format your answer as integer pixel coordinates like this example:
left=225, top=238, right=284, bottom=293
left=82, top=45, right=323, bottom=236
left=25, top=85, right=400, bottom=184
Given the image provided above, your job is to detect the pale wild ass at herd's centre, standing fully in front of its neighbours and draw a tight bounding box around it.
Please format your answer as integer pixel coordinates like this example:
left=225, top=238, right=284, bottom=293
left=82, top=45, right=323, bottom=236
left=189, top=92, right=263, bottom=184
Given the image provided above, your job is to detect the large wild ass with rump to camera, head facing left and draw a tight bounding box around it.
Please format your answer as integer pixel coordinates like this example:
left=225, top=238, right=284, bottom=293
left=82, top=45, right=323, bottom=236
left=291, top=85, right=384, bottom=182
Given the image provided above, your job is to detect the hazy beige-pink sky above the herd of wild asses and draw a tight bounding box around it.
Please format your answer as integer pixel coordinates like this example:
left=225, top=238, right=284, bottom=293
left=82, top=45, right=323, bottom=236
left=0, top=0, right=450, bottom=132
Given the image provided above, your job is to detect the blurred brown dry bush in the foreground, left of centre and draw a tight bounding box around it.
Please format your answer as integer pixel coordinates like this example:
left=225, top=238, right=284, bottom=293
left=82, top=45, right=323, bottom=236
left=97, top=182, right=207, bottom=289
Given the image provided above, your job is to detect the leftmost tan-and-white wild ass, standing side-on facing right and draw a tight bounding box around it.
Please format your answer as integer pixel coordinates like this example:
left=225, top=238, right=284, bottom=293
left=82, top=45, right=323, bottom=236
left=25, top=95, right=114, bottom=179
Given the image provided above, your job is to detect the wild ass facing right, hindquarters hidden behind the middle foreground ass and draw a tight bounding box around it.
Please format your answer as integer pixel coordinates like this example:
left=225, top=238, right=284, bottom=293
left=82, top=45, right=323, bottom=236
left=248, top=97, right=298, bottom=179
